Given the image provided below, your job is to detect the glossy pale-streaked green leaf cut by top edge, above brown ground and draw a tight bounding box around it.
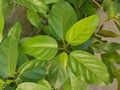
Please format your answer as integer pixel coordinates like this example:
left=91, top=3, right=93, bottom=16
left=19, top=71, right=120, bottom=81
left=16, top=0, right=49, bottom=14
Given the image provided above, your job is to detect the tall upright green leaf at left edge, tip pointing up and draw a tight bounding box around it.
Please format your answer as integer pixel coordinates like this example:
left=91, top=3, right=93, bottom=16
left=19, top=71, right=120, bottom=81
left=0, top=24, right=20, bottom=78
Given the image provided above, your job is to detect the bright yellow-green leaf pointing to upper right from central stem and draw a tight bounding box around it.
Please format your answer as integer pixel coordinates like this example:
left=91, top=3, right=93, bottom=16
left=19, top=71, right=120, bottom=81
left=66, top=15, right=99, bottom=46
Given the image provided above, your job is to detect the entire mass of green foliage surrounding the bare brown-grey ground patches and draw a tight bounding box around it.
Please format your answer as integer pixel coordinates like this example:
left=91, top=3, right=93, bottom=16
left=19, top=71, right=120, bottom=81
left=0, top=0, right=120, bottom=90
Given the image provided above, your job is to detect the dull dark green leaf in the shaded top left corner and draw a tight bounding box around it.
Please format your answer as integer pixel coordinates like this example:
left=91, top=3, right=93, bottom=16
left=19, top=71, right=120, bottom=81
left=2, top=0, right=15, bottom=17
